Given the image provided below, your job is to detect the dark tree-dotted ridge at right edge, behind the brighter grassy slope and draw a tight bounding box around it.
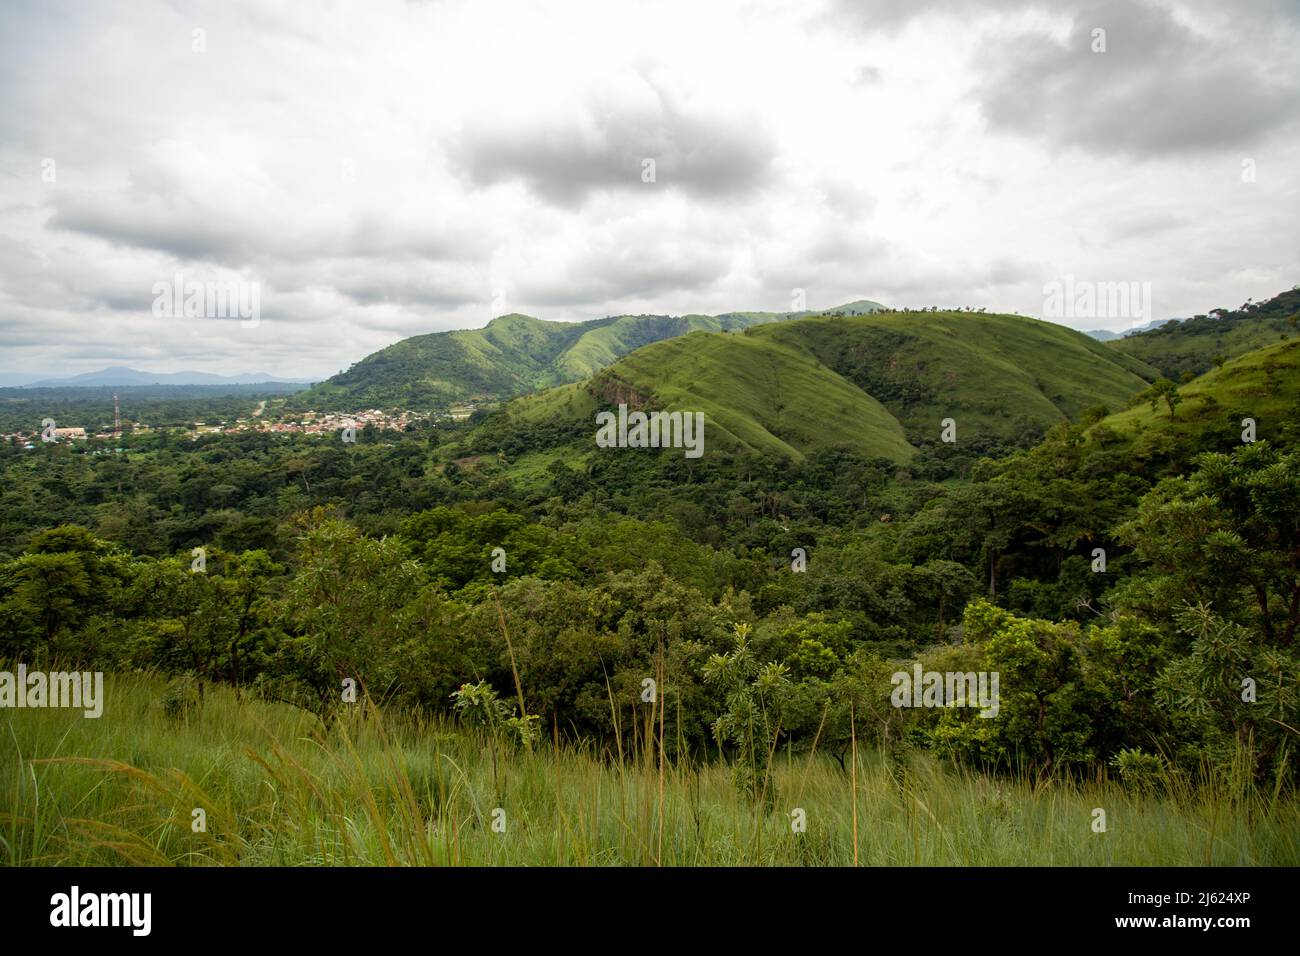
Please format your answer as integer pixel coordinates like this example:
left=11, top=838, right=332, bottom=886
left=1108, top=287, right=1300, bottom=381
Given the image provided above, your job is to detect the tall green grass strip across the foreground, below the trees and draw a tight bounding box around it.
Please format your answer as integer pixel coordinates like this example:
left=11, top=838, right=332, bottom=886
left=0, top=675, right=1300, bottom=866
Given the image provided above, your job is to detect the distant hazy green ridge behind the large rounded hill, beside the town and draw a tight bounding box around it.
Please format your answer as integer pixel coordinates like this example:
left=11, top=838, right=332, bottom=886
left=296, top=300, right=883, bottom=410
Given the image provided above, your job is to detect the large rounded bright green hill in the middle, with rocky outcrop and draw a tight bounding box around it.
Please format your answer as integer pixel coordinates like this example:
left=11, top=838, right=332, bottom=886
left=486, top=312, right=1156, bottom=463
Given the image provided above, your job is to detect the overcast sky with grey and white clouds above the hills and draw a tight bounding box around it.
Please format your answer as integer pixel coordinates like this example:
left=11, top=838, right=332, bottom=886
left=0, top=0, right=1300, bottom=377
